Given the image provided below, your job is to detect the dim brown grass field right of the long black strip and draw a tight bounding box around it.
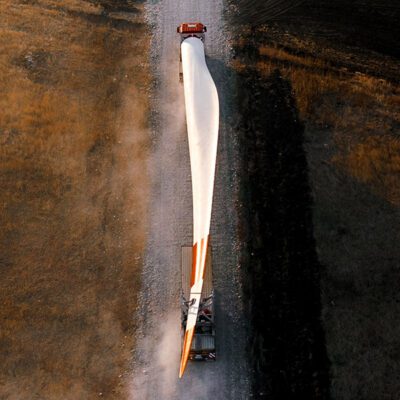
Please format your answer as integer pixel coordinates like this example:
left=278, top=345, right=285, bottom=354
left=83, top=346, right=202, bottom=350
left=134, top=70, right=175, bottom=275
left=233, top=6, right=400, bottom=400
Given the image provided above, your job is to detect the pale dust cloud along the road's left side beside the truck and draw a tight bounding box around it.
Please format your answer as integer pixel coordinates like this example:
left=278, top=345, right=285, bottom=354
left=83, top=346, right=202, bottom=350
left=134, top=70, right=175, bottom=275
left=130, top=41, right=191, bottom=400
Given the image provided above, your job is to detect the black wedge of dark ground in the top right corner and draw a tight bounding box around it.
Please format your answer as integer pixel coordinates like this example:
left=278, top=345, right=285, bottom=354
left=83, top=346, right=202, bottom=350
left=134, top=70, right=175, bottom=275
left=232, top=0, right=400, bottom=58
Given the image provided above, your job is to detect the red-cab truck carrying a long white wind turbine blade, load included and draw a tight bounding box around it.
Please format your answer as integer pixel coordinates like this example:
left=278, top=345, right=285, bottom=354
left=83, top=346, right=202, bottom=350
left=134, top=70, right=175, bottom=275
left=177, top=22, right=219, bottom=378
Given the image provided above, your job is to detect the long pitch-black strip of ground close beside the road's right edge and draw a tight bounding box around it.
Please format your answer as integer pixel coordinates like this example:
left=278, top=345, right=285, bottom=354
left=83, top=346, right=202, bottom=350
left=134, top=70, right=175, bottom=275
left=238, top=60, right=328, bottom=399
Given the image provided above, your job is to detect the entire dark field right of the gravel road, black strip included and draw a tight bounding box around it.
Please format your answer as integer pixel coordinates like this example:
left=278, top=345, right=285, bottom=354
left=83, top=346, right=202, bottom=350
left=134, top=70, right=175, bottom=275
left=229, top=1, right=400, bottom=400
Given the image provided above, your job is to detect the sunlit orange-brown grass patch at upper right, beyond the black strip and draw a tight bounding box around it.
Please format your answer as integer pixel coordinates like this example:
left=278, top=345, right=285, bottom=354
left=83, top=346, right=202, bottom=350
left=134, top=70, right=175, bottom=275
left=250, top=40, right=400, bottom=204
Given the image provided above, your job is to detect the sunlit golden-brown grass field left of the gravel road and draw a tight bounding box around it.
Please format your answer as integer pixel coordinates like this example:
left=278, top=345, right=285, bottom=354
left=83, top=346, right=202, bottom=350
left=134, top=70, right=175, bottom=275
left=0, top=0, right=149, bottom=400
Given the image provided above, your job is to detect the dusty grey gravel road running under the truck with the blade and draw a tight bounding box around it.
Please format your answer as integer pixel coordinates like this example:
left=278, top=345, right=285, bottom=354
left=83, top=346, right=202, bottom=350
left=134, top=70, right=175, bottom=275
left=132, top=0, right=249, bottom=400
